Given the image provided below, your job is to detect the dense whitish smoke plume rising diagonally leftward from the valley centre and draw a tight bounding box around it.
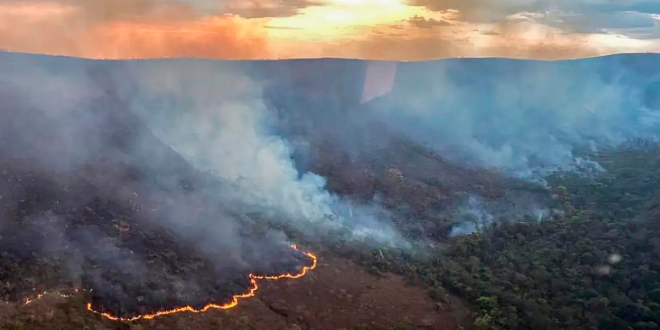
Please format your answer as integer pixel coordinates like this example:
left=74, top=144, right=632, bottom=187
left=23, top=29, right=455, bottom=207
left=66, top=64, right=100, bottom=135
left=118, top=61, right=403, bottom=245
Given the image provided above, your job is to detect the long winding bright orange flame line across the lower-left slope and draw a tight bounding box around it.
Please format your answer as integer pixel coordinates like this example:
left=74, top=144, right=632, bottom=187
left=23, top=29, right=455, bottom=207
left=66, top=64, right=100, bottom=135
left=87, top=244, right=317, bottom=322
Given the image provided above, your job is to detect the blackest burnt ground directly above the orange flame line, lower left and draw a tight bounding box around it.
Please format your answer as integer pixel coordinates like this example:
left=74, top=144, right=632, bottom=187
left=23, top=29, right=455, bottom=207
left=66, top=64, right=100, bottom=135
left=0, top=160, right=311, bottom=317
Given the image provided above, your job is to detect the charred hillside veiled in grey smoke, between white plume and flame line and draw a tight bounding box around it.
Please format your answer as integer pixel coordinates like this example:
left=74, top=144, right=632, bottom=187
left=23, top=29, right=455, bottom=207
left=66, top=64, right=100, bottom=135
left=0, top=63, right=312, bottom=318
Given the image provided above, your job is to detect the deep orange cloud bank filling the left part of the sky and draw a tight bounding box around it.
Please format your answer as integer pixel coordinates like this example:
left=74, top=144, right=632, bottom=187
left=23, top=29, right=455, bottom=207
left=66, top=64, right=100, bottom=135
left=0, top=0, right=267, bottom=58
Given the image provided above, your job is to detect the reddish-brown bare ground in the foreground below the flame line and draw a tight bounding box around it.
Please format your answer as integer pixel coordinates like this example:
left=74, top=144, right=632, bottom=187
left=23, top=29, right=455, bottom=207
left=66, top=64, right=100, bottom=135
left=0, top=253, right=469, bottom=330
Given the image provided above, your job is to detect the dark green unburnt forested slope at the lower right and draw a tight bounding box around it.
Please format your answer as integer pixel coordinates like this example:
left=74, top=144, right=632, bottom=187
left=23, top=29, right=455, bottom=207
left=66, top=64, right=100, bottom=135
left=430, top=143, right=660, bottom=330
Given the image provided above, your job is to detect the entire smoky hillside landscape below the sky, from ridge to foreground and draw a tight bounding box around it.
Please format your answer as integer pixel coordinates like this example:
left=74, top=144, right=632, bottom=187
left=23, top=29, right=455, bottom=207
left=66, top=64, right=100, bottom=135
left=0, top=53, right=660, bottom=330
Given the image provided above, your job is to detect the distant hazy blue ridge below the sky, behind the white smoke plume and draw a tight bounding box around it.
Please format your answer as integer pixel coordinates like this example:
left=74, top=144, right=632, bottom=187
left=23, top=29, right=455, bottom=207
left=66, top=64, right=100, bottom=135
left=0, top=53, right=660, bottom=236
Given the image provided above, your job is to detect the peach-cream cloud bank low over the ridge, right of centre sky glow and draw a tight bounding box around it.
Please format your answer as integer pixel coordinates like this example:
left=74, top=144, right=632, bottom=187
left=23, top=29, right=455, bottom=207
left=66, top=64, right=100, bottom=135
left=319, top=17, right=616, bottom=61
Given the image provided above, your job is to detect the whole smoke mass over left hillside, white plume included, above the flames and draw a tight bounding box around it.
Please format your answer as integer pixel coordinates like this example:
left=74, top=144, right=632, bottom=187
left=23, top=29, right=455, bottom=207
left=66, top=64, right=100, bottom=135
left=0, top=54, right=407, bottom=316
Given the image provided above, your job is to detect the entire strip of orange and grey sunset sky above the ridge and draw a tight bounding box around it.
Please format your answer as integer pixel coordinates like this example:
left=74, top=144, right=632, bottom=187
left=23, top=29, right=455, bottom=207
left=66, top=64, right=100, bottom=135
left=0, top=0, right=660, bottom=61
